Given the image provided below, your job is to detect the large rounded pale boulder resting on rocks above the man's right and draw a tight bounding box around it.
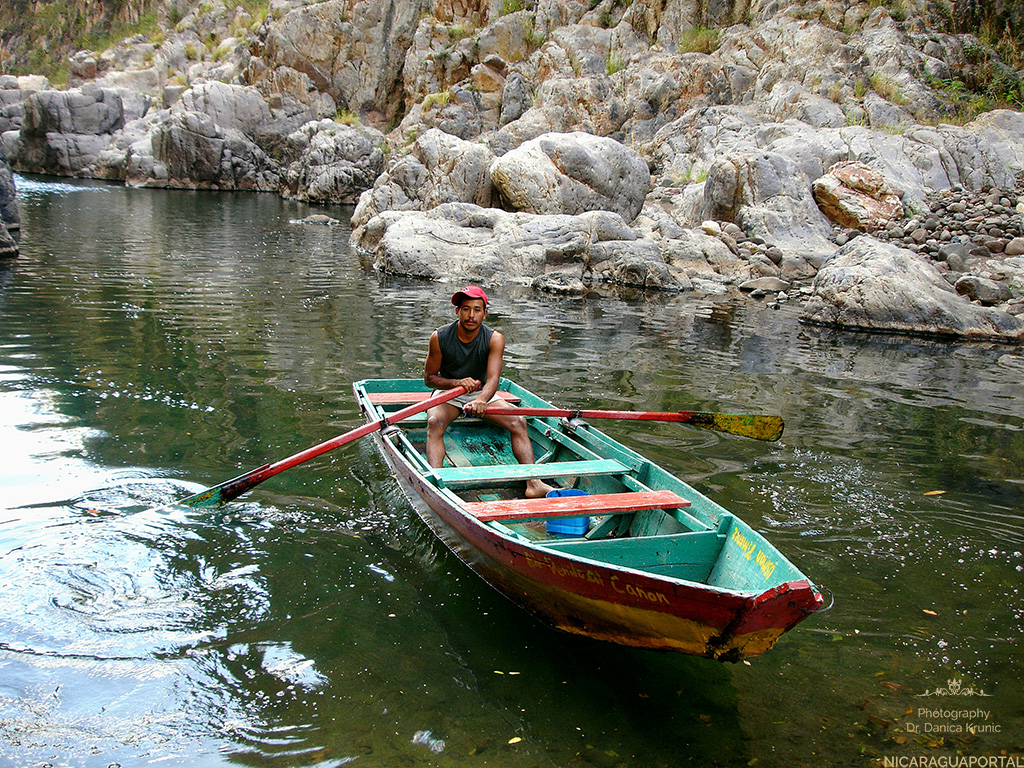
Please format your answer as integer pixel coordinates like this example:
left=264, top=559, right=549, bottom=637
left=490, top=132, right=650, bottom=221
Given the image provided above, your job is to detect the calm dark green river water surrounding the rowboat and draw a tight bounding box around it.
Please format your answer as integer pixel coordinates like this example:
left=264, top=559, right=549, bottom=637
left=0, top=178, right=1024, bottom=768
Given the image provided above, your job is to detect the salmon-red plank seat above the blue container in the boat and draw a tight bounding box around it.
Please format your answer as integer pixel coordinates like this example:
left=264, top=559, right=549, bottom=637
left=466, top=489, right=690, bottom=522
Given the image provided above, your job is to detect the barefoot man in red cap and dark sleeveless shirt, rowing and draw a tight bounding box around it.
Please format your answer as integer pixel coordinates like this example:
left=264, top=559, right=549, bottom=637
left=423, top=286, right=552, bottom=498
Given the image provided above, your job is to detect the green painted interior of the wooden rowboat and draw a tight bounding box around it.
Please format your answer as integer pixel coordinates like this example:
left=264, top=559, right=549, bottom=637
left=356, top=379, right=804, bottom=593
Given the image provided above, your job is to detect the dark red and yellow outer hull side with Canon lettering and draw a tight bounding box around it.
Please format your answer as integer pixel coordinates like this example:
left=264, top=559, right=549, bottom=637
left=360, top=378, right=822, bottom=662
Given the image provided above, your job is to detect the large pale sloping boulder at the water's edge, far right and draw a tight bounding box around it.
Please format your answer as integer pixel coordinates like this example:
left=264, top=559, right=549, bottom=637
left=801, top=238, right=1024, bottom=341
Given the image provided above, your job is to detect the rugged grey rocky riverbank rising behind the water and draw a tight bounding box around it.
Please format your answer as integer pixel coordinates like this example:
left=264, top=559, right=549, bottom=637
left=0, top=0, right=1024, bottom=342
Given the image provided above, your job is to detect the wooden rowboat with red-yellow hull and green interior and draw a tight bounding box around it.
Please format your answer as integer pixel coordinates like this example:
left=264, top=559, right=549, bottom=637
left=354, top=379, right=823, bottom=662
